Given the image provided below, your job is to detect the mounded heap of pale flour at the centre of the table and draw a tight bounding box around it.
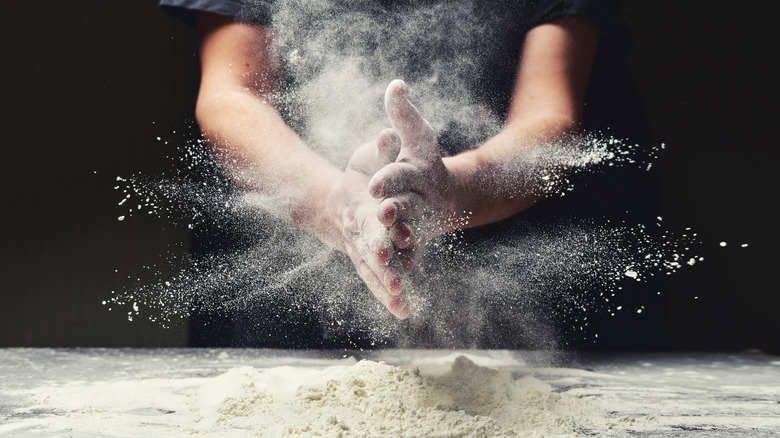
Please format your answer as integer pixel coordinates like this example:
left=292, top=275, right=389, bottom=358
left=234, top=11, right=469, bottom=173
left=187, top=356, right=605, bottom=437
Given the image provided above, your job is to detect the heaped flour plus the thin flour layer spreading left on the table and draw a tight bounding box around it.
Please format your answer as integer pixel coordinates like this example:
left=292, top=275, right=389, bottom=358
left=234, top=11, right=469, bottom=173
left=15, top=355, right=612, bottom=438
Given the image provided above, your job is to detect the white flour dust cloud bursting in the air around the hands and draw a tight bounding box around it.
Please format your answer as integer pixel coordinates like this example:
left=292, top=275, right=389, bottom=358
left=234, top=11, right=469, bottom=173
left=105, top=0, right=720, bottom=348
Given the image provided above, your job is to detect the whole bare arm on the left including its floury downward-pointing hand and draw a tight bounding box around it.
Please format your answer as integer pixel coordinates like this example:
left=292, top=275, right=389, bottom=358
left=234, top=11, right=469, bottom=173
left=196, top=13, right=408, bottom=318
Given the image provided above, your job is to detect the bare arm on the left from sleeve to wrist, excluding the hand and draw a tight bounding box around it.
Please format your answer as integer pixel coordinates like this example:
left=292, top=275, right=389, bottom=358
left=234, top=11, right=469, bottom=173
left=196, top=13, right=345, bottom=251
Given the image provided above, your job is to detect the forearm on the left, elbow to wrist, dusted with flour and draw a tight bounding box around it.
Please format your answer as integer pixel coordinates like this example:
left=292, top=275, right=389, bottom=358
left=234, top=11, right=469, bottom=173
left=196, top=83, right=344, bottom=251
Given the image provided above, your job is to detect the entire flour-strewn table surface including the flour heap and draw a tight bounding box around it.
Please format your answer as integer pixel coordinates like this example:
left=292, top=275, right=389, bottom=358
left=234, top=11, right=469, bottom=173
left=0, top=349, right=780, bottom=437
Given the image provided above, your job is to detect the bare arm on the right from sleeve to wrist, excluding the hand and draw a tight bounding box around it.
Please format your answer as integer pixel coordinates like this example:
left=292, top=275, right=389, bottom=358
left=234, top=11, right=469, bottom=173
left=444, top=17, right=598, bottom=236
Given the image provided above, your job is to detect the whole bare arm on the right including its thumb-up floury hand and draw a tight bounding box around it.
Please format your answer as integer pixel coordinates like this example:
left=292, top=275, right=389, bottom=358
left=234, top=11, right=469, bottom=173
left=370, top=17, right=598, bottom=264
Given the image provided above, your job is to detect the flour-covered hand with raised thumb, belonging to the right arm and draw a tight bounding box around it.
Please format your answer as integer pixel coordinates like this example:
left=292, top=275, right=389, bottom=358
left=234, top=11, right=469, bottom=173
left=368, top=80, right=457, bottom=270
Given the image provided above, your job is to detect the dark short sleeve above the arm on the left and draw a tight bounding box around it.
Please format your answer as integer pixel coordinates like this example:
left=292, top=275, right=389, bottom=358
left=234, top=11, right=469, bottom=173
left=160, top=0, right=271, bottom=26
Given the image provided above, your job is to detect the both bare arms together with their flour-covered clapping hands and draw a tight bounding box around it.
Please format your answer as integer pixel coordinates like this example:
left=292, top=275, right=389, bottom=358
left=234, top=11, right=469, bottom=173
left=196, top=13, right=598, bottom=326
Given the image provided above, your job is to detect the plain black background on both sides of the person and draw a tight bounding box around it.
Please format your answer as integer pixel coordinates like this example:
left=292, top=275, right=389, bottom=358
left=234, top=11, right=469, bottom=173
left=0, top=0, right=780, bottom=353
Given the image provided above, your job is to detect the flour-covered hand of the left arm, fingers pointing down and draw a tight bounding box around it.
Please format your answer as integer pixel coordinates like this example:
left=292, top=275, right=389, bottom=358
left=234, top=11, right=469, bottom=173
left=342, top=129, right=411, bottom=319
